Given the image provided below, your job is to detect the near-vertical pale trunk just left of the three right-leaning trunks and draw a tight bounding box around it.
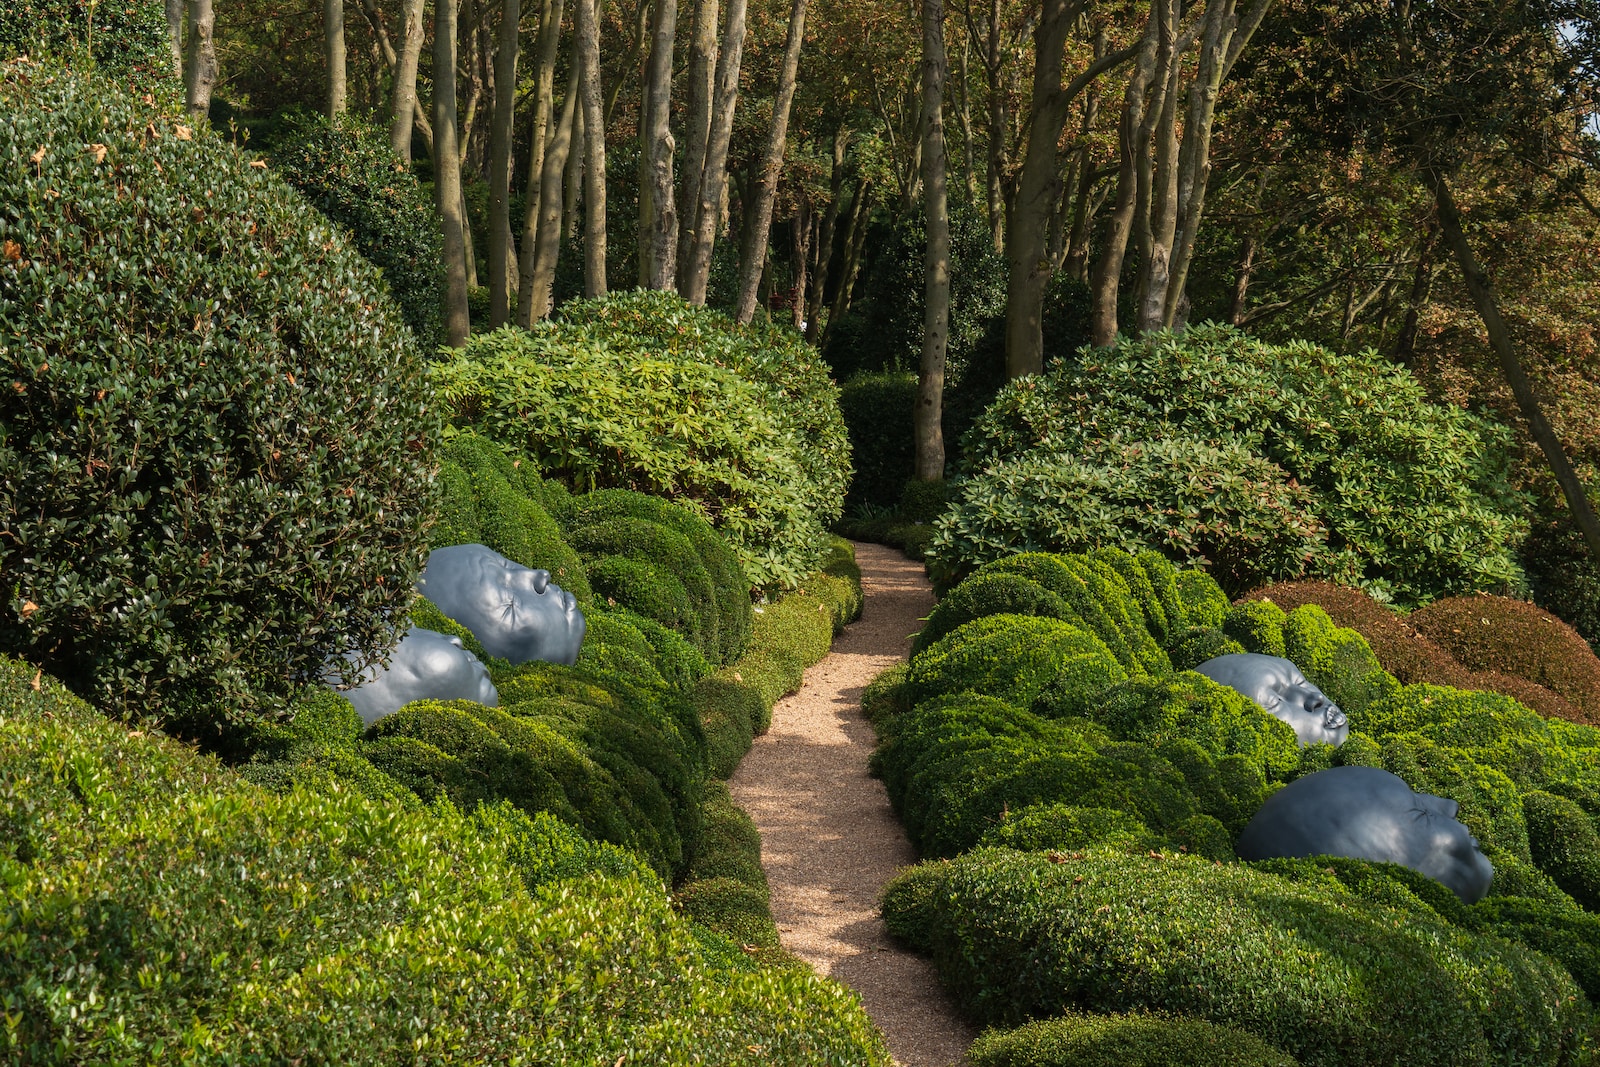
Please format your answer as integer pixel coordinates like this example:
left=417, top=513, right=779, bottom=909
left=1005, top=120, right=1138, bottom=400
left=638, top=0, right=678, bottom=290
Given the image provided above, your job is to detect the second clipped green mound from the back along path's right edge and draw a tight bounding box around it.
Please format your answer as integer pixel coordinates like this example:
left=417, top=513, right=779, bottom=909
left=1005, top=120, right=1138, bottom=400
left=906, top=614, right=1110, bottom=707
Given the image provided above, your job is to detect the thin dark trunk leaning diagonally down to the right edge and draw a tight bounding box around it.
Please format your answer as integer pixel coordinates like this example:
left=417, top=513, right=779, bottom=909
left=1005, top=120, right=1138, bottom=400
left=1424, top=170, right=1600, bottom=560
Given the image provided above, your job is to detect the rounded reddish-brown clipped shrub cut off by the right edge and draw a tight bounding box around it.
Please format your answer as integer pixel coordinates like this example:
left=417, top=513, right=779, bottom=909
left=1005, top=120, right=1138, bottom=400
left=1411, top=595, right=1600, bottom=718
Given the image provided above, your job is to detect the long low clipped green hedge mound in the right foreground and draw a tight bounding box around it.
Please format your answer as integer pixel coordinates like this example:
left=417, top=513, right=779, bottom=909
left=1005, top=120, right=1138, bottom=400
left=883, top=851, right=1587, bottom=1067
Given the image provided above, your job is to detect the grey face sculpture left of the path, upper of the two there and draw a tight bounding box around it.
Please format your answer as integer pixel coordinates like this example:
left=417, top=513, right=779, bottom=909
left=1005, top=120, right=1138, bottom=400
left=416, top=544, right=587, bottom=664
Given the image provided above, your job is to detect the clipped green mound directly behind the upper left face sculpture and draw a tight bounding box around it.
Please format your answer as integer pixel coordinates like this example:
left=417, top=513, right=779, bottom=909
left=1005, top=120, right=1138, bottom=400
left=429, top=434, right=594, bottom=606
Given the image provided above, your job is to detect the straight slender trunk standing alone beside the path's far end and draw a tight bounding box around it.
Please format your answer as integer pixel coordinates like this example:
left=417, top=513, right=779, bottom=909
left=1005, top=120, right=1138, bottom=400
left=912, top=0, right=950, bottom=482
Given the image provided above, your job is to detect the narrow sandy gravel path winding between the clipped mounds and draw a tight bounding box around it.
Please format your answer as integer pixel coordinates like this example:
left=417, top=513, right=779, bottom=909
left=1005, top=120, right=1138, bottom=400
left=728, top=544, right=976, bottom=1067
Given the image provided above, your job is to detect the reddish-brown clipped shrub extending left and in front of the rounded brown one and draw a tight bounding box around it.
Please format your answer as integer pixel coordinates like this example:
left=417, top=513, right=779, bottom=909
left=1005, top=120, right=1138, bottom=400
left=1243, top=582, right=1600, bottom=723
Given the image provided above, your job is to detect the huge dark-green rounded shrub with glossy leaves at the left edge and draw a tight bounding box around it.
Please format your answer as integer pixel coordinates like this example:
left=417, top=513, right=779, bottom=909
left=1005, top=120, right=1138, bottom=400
left=0, top=64, right=437, bottom=721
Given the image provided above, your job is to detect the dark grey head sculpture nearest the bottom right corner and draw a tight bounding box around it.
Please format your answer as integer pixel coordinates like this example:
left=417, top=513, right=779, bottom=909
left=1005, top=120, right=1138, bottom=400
left=1235, top=766, right=1494, bottom=904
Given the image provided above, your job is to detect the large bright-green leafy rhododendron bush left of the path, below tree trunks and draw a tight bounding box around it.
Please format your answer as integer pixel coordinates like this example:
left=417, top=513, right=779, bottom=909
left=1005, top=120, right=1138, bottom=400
left=432, top=291, right=850, bottom=589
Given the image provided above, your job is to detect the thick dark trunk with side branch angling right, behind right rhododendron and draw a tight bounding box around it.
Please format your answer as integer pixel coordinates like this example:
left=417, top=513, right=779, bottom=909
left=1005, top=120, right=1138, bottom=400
left=1005, top=0, right=1134, bottom=378
